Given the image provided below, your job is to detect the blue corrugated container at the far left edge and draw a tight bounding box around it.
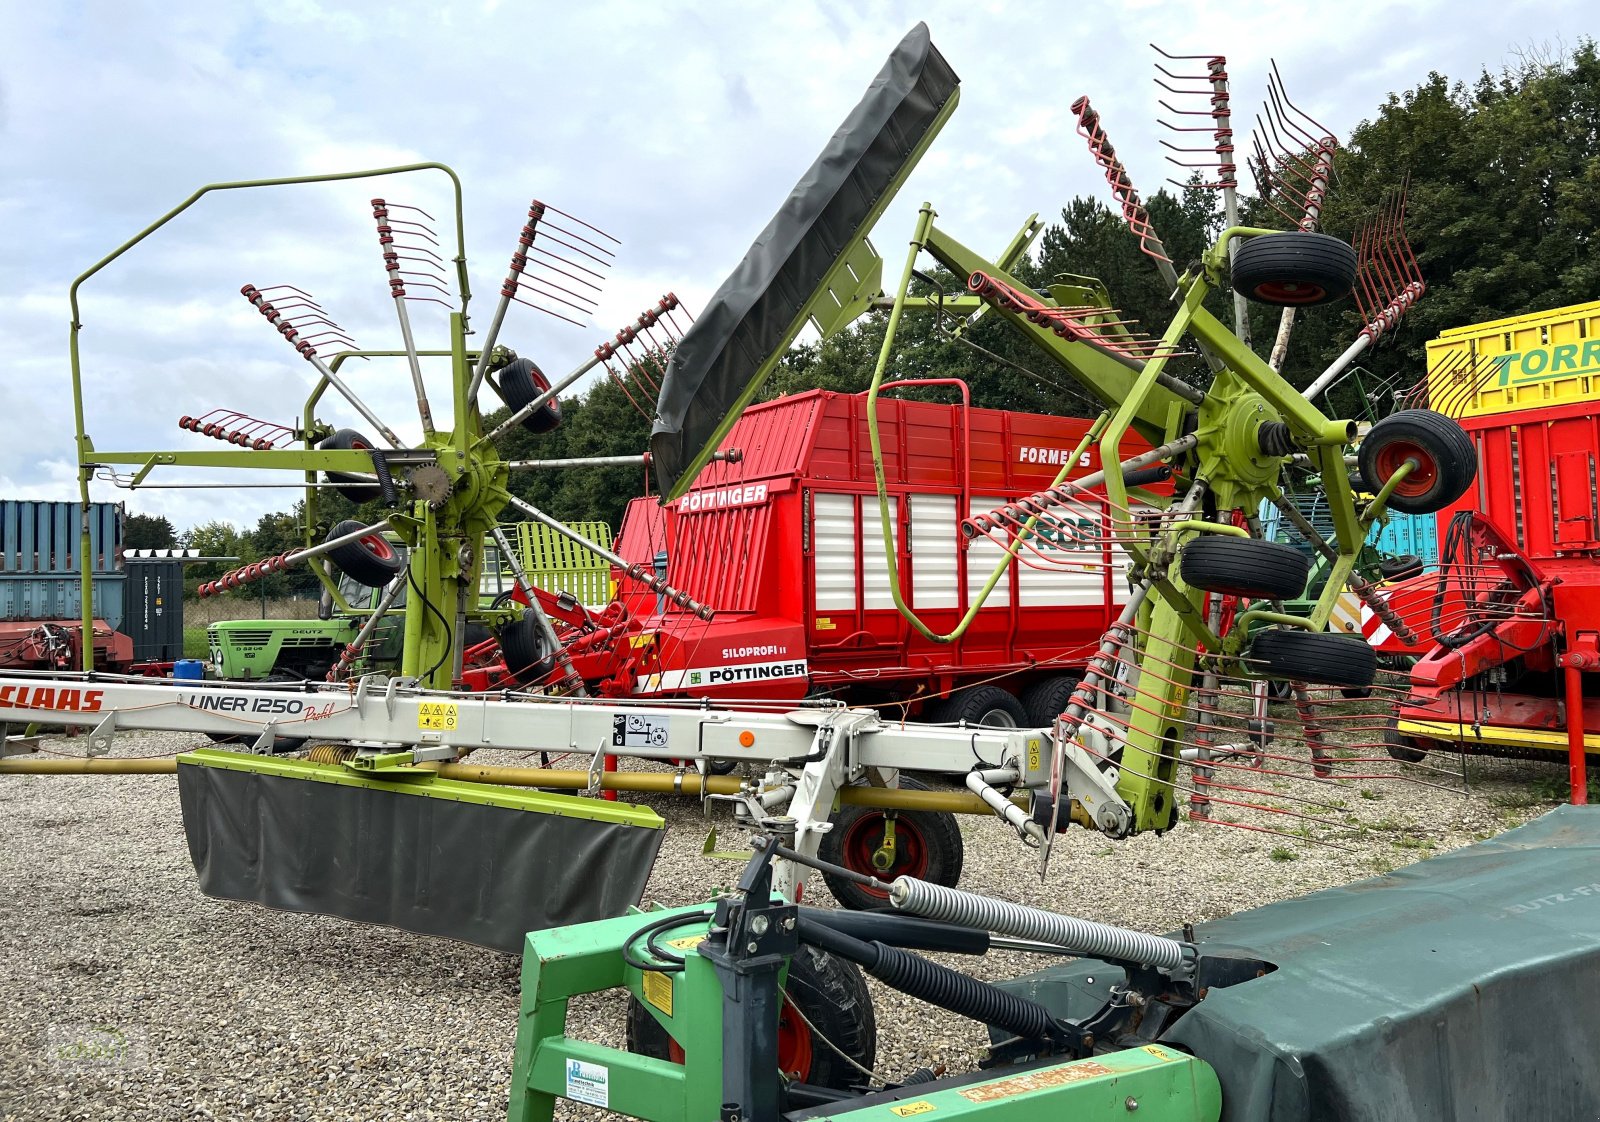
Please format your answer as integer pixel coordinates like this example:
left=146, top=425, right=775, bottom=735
left=0, top=499, right=126, bottom=629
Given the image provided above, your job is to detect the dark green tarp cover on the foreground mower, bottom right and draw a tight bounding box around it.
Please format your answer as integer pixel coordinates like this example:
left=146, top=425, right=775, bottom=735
left=1005, top=807, right=1600, bottom=1122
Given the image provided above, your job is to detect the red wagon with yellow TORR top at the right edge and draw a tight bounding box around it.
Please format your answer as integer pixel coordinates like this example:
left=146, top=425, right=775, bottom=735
left=1395, top=303, right=1600, bottom=777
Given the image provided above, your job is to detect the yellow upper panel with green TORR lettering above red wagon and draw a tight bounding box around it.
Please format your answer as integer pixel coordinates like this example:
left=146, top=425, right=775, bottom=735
left=1427, top=301, right=1600, bottom=418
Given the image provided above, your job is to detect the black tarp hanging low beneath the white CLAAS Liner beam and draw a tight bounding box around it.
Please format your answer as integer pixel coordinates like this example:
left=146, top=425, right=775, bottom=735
left=178, top=752, right=664, bottom=954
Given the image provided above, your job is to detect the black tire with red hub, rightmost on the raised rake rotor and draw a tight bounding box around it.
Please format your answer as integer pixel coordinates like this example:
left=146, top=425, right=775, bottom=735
left=1357, top=410, right=1478, bottom=514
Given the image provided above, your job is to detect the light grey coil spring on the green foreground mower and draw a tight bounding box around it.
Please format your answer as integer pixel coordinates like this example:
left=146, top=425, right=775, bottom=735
left=890, top=877, right=1194, bottom=970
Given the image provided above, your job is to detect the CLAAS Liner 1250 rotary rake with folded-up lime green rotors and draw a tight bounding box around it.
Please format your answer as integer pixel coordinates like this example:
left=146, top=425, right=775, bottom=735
left=0, top=27, right=1472, bottom=948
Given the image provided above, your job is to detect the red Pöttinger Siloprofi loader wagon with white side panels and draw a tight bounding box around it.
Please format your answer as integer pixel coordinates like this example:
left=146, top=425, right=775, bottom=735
left=588, top=383, right=1164, bottom=725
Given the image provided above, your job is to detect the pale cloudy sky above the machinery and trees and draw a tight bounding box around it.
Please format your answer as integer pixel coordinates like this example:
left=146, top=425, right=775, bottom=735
left=0, top=0, right=1600, bottom=527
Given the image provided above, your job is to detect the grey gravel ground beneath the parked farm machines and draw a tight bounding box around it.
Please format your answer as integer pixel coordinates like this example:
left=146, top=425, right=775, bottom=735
left=0, top=733, right=1555, bottom=1122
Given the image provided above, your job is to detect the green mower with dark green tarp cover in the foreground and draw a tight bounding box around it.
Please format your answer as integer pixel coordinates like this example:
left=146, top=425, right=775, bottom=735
left=507, top=807, right=1600, bottom=1122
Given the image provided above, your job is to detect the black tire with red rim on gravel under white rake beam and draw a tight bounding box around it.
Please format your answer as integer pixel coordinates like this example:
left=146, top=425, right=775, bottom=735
left=818, top=771, right=966, bottom=912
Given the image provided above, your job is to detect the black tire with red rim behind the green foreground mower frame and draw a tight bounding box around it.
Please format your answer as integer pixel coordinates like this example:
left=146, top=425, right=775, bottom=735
left=627, top=943, right=878, bottom=1090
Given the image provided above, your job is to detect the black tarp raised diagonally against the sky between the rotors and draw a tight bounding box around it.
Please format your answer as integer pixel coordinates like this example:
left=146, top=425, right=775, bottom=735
left=650, top=24, right=960, bottom=499
